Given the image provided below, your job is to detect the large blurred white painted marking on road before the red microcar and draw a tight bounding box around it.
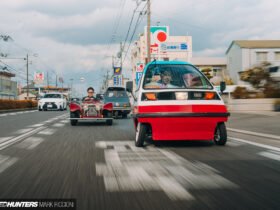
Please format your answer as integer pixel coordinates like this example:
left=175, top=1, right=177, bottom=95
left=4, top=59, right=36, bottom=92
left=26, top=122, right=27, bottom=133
left=95, top=141, right=238, bottom=200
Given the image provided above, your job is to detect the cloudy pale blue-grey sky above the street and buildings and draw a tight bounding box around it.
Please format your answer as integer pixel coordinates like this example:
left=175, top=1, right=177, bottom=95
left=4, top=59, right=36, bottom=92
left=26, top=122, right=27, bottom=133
left=0, top=0, right=280, bottom=95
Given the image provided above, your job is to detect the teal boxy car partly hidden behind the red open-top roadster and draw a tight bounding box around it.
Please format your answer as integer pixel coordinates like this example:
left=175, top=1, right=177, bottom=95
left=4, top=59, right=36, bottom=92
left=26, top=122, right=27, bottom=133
left=104, top=87, right=131, bottom=118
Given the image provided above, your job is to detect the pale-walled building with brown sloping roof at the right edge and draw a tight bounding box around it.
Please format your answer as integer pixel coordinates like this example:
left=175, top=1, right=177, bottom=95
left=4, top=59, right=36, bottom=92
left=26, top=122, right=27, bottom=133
left=226, top=40, right=280, bottom=84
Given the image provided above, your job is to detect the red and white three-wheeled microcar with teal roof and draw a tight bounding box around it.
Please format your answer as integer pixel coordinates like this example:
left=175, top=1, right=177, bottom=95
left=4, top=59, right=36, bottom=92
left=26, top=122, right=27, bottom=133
left=127, top=61, right=230, bottom=147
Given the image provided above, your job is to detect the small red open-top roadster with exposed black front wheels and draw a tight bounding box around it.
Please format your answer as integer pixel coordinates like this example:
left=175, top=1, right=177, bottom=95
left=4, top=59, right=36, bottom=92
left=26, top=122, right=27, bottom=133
left=69, top=98, right=113, bottom=126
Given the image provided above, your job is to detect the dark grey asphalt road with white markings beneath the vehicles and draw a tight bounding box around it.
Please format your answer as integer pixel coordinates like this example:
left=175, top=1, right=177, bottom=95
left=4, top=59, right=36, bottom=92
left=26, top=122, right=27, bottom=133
left=0, top=111, right=280, bottom=210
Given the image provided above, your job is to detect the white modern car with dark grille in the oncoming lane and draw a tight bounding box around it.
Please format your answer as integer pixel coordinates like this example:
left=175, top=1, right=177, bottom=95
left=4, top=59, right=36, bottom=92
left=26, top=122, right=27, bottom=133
left=38, top=93, right=67, bottom=111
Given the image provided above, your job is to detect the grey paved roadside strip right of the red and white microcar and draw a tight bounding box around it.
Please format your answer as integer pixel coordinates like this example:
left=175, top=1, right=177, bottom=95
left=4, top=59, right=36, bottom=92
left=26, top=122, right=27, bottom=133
left=227, top=112, right=280, bottom=136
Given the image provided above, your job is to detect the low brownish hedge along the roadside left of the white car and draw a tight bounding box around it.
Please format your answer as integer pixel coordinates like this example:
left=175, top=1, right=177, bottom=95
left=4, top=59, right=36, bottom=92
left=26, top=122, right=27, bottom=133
left=0, top=99, right=38, bottom=110
